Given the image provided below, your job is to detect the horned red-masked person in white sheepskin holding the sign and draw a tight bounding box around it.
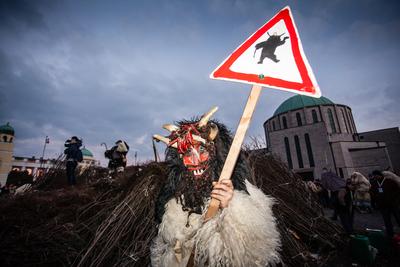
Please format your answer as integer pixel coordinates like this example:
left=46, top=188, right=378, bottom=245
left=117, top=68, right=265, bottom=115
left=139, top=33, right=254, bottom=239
left=151, top=108, right=280, bottom=267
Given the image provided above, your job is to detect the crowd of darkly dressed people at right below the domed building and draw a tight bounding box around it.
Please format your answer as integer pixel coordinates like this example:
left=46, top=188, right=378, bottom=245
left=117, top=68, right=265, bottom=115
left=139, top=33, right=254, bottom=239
left=309, top=168, right=400, bottom=238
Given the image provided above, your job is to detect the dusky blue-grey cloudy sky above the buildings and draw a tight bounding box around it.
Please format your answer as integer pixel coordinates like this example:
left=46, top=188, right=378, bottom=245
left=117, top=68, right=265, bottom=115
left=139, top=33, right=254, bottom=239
left=0, top=0, right=400, bottom=165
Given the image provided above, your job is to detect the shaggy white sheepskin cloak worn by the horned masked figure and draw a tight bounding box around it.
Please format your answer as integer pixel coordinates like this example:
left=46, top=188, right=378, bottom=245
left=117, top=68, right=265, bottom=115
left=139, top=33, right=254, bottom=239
left=151, top=181, right=280, bottom=267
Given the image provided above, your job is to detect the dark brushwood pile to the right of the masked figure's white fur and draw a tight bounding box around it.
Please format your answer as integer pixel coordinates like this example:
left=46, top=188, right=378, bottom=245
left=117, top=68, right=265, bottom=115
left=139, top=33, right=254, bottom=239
left=248, top=152, right=346, bottom=266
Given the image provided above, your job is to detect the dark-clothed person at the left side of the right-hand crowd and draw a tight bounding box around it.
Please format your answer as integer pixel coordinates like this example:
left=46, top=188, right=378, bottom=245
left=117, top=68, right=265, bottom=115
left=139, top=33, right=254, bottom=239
left=321, top=168, right=353, bottom=234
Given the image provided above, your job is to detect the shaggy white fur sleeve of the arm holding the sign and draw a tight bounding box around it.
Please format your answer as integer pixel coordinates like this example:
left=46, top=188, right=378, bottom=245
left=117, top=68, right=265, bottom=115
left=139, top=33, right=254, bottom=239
left=195, top=182, right=280, bottom=267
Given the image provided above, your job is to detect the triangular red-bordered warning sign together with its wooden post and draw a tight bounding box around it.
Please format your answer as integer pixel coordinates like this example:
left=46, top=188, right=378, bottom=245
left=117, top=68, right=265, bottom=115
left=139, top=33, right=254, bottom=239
left=187, top=6, right=321, bottom=266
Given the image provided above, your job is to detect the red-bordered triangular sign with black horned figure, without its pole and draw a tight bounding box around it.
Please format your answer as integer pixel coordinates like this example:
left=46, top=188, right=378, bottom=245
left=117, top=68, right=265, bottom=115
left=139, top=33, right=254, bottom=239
left=210, top=6, right=321, bottom=97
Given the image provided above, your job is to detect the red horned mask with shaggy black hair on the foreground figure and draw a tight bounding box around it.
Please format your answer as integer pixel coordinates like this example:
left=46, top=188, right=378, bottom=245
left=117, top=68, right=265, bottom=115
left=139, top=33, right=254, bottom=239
left=153, top=107, right=248, bottom=220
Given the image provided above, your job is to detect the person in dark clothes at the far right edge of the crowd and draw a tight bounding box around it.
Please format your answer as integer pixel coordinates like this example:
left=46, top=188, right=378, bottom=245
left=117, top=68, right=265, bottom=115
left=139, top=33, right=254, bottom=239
left=370, top=170, right=400, bottom=238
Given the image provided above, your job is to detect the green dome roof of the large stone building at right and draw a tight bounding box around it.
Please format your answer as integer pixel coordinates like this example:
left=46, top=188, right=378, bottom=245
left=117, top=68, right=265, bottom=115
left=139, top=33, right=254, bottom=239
left=274, top=95, right=335, bottom=116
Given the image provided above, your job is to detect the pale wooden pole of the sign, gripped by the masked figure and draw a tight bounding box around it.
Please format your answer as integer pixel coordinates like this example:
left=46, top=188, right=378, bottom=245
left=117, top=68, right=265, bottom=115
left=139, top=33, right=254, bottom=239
left=204, top=85, right=262, bottom=221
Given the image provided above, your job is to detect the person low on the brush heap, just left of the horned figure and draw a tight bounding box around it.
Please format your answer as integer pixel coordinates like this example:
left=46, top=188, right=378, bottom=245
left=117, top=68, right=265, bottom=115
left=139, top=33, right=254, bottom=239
left=104, top=140, right=129, bottom=173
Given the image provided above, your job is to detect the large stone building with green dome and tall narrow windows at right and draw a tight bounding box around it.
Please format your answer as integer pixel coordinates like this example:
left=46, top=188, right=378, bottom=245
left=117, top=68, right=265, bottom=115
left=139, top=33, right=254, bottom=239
left=264, top=95, right=392, bottom=180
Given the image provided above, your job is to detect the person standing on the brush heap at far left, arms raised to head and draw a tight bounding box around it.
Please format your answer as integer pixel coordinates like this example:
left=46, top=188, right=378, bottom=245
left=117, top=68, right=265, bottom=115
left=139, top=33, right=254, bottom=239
left=64, top=136, right=83, bottom=186
